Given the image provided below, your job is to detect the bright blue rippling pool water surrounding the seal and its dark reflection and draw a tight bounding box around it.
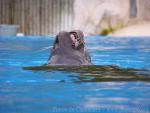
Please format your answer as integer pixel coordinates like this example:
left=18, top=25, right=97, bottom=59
left=0, top=37, right=150, bottom=113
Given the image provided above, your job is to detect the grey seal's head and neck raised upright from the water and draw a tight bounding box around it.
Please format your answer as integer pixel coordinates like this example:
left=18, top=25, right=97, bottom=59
left=48, top=30, right=92, bottom=66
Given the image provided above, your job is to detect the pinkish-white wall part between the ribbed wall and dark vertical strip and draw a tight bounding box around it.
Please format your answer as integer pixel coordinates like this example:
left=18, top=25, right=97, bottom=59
left=74, top=0, right=129, bottom=34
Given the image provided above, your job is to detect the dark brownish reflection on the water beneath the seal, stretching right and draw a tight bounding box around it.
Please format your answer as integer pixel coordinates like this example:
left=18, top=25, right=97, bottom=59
left=23, top=65, right=150, bottom=82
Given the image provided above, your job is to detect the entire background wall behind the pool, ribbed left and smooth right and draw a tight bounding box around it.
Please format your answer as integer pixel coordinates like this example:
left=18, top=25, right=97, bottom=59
left=0, top=0, right=150, bottom=35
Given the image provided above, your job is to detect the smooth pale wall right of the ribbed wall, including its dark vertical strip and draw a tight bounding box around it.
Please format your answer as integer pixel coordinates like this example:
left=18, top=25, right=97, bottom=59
left=74, top=0, right=150, bottom=35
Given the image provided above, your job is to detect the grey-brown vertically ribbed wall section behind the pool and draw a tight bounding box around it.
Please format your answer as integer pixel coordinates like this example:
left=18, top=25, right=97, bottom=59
left=0, top=0, right=74, bottom=35
